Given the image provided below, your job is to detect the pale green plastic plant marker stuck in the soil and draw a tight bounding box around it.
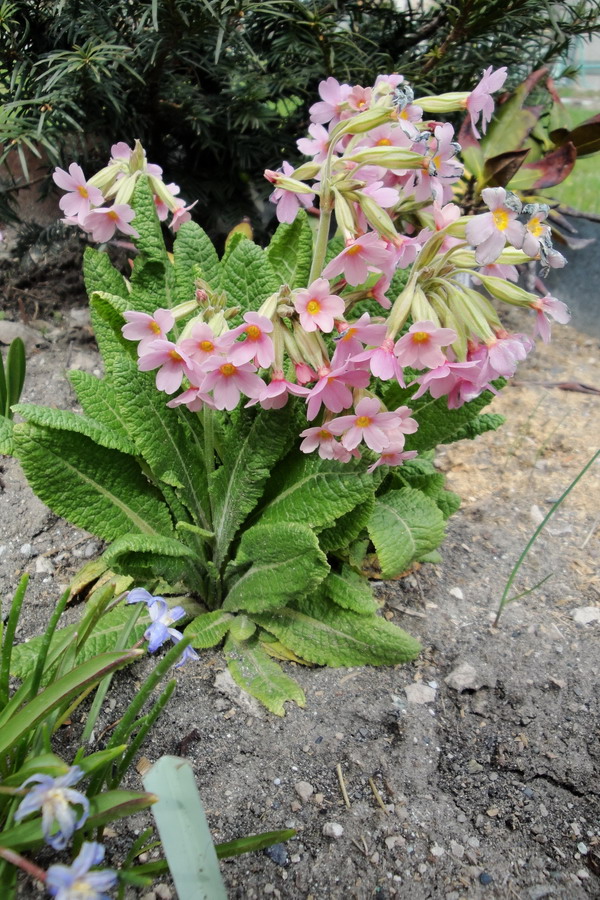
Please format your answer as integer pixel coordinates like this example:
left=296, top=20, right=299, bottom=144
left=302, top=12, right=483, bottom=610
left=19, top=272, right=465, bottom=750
left=142, top=756, right=227, bottom=900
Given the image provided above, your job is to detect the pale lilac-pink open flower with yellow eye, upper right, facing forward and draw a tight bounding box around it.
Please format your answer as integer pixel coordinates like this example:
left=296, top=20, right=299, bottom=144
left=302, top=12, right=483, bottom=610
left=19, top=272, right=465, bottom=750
left=466, top=188, right=525, bottom=266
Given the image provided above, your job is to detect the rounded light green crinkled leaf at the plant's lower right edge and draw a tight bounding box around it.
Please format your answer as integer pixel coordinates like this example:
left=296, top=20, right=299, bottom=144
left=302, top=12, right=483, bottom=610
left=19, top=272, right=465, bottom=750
left=367, top=487, right=444, bottom=578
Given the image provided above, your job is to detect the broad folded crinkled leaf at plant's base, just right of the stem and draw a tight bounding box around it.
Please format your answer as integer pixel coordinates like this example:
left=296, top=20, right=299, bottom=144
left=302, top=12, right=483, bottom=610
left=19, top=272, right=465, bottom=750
left=223, top=523, right=329, bottom=612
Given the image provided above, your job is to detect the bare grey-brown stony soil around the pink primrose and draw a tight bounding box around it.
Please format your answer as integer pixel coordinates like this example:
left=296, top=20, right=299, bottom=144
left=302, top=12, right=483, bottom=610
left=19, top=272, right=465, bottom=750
left=0, top=248, right=600, bottom=900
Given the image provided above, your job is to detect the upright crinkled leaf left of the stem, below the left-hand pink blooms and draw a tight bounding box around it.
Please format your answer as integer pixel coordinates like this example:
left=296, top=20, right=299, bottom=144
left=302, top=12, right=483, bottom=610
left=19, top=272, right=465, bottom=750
left=112, top=354, right=210, bottom=528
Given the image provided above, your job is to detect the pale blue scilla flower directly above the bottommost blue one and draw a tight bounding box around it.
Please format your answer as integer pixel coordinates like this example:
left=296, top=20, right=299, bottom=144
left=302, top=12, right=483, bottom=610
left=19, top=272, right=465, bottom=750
left=15, top=766, right=90, bottom=850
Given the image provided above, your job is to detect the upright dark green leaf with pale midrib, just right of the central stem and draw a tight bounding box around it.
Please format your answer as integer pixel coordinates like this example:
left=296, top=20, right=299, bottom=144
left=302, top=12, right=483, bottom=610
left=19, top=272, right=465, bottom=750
left=209, top=403, right=298, bottom=566
